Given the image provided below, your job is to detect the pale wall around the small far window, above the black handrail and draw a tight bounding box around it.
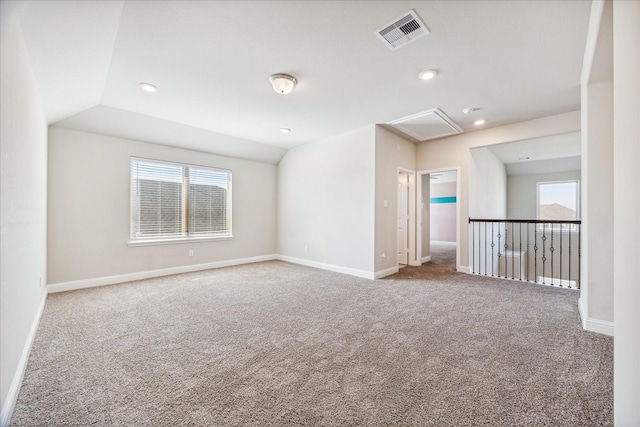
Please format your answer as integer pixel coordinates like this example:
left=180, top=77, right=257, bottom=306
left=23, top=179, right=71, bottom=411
left=507, top=170, right=580, bottom=219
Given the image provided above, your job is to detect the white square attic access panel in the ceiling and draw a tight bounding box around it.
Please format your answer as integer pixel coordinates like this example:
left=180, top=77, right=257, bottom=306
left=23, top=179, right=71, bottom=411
left=387, top=108, right=463, bottom=142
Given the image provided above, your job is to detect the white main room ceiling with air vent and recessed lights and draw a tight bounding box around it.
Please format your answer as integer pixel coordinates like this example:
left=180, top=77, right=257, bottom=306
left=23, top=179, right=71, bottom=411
left=10, top=0, right=591, bottom=162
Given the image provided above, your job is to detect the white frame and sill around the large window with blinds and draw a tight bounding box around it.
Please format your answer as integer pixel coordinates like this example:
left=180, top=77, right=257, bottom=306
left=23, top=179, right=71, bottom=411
left=127, top=156, right=234, bottom=247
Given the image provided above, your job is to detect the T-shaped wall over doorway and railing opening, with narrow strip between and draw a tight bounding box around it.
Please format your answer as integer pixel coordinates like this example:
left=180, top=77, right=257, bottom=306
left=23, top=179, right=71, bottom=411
left=417, top=111, right=580, bottom=270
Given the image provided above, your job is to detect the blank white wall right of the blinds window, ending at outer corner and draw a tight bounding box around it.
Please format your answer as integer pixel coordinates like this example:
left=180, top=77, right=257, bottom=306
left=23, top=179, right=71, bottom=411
left=277, top=126, right=378, bottom=277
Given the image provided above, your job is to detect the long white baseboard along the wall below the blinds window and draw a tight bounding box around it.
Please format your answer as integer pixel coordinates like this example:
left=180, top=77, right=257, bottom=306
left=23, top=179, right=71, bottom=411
left=47, top=254, right=277, bottom=293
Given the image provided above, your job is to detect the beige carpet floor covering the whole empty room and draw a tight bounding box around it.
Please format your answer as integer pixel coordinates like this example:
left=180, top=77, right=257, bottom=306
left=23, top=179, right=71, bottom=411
left=11, top=261, right=613, bottom=426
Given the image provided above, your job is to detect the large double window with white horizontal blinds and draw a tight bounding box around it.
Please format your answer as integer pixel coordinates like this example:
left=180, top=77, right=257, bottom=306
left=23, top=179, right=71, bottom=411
left=131, top=158, right=231, bottom=242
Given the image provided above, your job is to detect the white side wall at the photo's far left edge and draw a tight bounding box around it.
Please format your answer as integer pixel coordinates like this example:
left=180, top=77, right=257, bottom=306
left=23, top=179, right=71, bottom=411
left=0, top=1, right=47, bottom=425
